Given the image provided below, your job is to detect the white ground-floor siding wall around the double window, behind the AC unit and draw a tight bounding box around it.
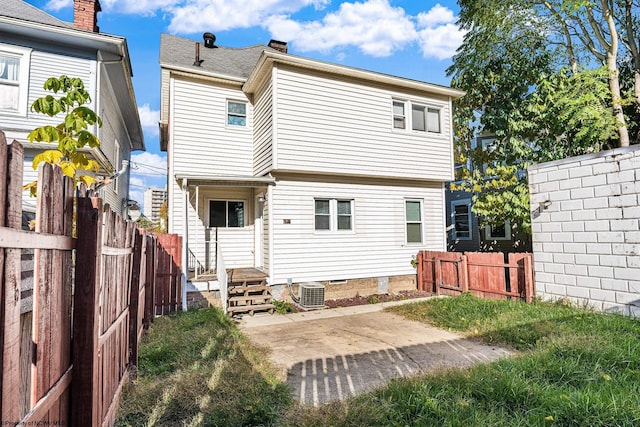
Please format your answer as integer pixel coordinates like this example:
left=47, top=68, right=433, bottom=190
left=268, top=179, right=446, bottom=284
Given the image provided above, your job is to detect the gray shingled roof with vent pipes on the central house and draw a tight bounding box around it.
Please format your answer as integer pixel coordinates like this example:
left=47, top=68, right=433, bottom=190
left=160, top=33, right=275, bottom=79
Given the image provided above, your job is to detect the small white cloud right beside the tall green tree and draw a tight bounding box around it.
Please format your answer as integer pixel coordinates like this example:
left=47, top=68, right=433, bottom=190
left=418, top=4, right=465, bottom=59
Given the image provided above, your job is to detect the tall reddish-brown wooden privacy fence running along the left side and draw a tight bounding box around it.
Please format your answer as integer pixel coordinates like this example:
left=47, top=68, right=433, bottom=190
left=0, top=131, right=181, bottom=426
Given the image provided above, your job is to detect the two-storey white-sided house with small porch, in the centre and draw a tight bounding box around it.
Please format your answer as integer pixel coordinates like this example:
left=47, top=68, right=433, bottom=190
left=160, top=33, right=463, bottom=300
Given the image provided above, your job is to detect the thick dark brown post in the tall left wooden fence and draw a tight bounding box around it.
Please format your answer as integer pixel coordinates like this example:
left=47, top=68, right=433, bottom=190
left=71, top=197, right=103, bottom=426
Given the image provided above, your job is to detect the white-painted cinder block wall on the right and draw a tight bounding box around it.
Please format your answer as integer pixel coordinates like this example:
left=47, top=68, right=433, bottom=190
left=528, top=146, right=640, bottom=316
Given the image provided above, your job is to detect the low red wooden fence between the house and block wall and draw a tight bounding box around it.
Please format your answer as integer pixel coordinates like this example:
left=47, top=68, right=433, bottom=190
left=418, top=251, right=534, bottom=302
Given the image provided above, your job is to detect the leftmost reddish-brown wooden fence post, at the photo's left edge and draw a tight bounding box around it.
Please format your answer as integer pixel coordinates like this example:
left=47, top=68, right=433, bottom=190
left=0, top=137, right=24, bottom=422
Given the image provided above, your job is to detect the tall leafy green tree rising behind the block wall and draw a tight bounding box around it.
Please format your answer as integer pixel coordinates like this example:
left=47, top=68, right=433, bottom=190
left=448, top=0, right=638, bottom=231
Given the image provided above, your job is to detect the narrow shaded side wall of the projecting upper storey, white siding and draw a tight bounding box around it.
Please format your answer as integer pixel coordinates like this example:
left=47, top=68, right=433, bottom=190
left=253, top=80, right=273, bottom=176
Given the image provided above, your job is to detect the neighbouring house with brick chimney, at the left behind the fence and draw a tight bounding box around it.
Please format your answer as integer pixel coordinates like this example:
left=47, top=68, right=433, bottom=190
left=0, top=0, right=144, bottom=213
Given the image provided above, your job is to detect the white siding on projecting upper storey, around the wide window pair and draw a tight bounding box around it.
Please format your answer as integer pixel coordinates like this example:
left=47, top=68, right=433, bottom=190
left=274, top=66, right=453, bottom=181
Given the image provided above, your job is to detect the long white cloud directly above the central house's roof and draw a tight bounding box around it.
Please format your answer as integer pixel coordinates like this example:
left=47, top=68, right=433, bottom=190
left=265, top=0, right=417, bottom=56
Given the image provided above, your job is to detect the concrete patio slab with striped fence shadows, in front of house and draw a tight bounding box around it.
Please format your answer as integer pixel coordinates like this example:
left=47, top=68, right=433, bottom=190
left=240, top=300, right=511, bottom=405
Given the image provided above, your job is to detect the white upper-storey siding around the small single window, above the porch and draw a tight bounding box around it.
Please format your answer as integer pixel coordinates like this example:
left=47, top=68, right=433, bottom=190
left=171, top=77, right=253, bottom=176
